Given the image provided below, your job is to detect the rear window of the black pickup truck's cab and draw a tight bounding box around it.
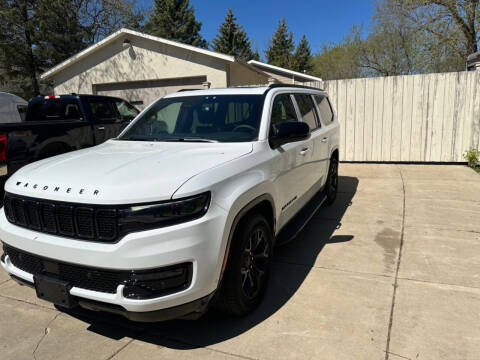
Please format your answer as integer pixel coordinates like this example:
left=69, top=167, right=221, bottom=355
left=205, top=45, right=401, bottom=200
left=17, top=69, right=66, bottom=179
left=25, top=98, right=82, bottom=121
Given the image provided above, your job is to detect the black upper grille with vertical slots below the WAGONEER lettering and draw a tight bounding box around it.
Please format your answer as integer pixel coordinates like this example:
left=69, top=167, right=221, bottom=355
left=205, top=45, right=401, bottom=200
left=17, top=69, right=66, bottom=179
left=4, top=194, right=118, bottom=242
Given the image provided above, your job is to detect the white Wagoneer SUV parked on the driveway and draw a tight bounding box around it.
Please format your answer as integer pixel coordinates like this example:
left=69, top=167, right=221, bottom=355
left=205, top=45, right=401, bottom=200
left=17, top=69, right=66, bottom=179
left=0, top=85, right=339, bottom=321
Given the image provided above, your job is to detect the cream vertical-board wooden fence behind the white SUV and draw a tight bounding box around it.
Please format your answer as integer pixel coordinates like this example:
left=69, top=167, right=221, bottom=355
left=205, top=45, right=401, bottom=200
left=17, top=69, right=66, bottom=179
left=325, top=70, right=480, bottom=162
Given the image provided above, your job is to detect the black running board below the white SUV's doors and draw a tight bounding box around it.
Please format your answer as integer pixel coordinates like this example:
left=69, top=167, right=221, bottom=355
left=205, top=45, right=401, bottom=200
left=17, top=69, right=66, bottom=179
left=275, top=189, right=327, bottom=245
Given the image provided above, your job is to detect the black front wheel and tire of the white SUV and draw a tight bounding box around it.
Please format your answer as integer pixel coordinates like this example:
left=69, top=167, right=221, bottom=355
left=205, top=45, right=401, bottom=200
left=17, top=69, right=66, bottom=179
left=216, top=214, right=273, bottom=316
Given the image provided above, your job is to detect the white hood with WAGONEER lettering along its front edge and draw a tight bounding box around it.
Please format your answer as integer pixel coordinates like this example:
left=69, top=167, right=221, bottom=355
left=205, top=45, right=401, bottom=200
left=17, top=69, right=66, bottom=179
left=5, top=140, right=253, bottom=204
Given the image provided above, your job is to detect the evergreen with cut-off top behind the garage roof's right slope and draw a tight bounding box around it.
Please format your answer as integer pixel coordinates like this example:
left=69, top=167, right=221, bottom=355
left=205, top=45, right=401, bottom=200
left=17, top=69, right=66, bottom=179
left=145, top=0, right=208, bottom=48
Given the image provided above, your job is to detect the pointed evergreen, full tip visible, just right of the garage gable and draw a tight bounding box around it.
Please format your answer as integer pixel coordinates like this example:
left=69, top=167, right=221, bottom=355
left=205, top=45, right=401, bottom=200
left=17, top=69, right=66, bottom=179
left=213, top=9, right=258, bottom=61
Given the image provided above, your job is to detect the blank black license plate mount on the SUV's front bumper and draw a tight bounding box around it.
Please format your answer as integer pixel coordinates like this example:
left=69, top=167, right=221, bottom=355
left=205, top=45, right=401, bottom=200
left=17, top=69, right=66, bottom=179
left=33, top=275, right=77, bottom=308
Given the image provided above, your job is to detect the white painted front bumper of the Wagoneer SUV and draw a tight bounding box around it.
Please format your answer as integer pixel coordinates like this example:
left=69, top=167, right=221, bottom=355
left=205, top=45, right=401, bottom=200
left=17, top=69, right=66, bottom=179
left=0, top=203, right=227, bottom=321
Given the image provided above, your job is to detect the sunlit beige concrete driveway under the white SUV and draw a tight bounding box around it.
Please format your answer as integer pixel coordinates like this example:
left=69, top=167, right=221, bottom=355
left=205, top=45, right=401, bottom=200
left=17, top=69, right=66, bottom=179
left=0, top=164, right=480, bottom=360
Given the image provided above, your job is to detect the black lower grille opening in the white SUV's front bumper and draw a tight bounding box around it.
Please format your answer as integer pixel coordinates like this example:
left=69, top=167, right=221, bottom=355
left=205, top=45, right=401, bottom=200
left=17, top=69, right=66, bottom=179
left=3, top=244, right=192, bottom=299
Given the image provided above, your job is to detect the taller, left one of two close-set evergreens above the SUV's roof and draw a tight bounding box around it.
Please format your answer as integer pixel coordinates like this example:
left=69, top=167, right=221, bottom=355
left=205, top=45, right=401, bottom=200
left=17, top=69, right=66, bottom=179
left=265, top=18, right=295, bottom=68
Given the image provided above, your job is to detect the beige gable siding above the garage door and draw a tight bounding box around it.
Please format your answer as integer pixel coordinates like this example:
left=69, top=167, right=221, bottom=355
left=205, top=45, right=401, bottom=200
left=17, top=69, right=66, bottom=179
left=53, top=35, right=228, bottom=94
